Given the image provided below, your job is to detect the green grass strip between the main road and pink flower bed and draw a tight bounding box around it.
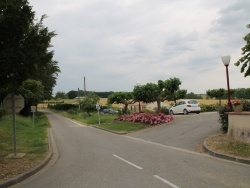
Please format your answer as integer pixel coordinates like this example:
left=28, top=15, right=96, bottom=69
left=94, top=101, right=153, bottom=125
left=58, top=112, right=150, bottom=133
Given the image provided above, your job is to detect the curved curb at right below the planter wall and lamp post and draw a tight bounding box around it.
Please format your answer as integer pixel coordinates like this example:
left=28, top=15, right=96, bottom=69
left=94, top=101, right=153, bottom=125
left=203, top=137, right=250, bottom=165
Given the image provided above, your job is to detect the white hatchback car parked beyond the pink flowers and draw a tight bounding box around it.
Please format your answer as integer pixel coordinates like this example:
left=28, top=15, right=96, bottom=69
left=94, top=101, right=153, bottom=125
left=169, top=100, right=201, bottom=115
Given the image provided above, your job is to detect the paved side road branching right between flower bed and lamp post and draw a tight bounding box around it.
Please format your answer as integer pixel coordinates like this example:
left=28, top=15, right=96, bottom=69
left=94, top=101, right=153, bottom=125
left=129, top=112, right=221, bottom=151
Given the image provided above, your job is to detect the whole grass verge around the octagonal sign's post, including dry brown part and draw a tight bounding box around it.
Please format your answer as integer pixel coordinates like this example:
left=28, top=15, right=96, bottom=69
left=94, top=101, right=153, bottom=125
left=0, top=113, right=49, bottom=182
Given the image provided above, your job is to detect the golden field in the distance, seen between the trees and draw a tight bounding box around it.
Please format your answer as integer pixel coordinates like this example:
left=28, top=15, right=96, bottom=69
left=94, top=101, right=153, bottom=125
left=38, top=98, right=227, bottom=108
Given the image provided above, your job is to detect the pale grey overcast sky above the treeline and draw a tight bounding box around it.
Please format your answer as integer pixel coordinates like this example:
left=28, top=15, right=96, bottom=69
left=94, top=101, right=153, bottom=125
left=29, top=0, right=250, bottom=94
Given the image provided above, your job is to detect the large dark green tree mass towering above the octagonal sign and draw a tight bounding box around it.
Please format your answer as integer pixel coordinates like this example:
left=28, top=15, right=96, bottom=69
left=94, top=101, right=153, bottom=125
left=0, top=0, right=60, bottom=99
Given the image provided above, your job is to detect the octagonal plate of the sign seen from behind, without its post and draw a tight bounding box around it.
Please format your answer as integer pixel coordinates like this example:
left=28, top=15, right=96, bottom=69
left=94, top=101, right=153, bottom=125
left=3, top=93, right=24, bottom=114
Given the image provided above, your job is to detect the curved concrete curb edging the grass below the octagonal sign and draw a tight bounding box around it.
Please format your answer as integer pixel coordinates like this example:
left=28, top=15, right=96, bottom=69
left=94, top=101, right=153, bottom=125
left=0, top=128, right=53, bottom=188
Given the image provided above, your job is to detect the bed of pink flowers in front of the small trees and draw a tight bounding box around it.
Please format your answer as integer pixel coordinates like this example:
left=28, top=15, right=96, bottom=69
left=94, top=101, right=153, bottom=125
left=115, top=113, right=174, bottom=125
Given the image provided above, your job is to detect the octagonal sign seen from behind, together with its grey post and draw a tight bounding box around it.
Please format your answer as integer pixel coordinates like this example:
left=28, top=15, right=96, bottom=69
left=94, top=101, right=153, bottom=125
left=3, top=93, right=24, bottom=157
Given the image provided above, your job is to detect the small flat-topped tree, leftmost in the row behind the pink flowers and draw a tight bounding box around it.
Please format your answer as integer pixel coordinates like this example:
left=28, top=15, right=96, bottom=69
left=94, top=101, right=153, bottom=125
left=108, top=91, right=135, bottom=114
